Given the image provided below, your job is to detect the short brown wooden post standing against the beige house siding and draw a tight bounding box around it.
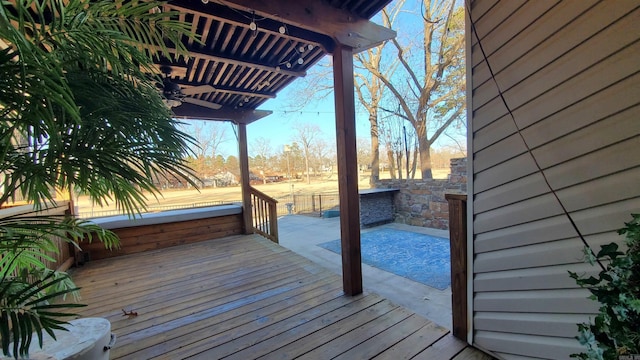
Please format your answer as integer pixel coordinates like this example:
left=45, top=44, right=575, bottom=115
left=444, top=194, right=469, bottom=342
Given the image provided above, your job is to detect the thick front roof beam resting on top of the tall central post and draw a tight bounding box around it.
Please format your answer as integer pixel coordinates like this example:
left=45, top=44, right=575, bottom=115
left=218, top=0, right=396, bottom=52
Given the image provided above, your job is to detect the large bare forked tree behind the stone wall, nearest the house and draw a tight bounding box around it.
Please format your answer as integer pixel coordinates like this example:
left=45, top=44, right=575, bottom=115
left=361, top=0, right=465, bottom=178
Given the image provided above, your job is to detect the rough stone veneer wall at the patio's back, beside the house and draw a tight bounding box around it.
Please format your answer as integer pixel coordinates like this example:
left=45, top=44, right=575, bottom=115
left=376, top=158, right=467, bottom=230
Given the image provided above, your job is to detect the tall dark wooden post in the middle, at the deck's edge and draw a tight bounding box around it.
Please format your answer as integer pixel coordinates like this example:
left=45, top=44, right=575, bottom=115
left=333, top=45, right=362, bottom=295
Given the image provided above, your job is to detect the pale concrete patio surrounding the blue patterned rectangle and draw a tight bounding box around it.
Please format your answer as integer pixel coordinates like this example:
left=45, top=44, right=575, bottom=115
left=278, top=215, right=452, bottom=329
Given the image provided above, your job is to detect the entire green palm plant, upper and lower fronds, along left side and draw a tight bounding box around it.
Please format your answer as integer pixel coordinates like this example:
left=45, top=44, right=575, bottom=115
left=0, top=0, right=197, bottom=358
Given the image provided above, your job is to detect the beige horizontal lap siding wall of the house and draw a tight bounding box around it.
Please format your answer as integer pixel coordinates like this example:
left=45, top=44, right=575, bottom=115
left=468, top=0, right=640, bottom=359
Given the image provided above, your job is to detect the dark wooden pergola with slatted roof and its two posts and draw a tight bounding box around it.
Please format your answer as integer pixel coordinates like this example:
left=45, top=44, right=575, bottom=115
left=159, top=0, right=395, bottom=295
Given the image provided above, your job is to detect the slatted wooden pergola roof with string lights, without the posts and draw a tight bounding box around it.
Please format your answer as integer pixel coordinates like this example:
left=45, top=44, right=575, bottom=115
left=159, top=0, right=394, bottom=123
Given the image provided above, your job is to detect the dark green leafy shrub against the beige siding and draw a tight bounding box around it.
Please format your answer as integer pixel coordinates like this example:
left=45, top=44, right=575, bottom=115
left=569, top=214, right=640, bottom=359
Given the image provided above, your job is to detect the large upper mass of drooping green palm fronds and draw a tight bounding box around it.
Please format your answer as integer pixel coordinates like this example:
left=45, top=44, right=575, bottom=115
left=0, top=0, right=197, bottom=214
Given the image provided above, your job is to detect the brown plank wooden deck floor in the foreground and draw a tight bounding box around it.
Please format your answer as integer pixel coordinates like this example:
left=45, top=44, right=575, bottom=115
left=72, top=235, right=490, bottom=360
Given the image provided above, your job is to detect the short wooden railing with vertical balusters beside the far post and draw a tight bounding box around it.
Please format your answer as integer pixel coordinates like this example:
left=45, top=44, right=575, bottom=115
left=249, top=186, right=278, bottom=244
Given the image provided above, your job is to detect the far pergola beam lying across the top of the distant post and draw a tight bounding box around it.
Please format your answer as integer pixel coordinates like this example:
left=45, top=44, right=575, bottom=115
left=171, top=103, right=273, bottom=124
